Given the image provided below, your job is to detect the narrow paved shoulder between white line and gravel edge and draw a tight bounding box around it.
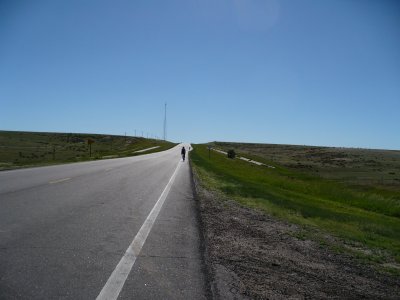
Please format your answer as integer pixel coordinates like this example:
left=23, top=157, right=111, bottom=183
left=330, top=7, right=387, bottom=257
left=119, top=161, right=210, bottom=299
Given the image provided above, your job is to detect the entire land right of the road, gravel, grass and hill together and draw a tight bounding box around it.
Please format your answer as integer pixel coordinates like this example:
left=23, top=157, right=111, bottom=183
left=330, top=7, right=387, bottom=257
left=190, top=142, right=400, bottom=299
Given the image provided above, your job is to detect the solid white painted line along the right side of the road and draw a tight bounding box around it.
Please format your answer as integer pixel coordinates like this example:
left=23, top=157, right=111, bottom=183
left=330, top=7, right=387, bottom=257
left=96, top=162, right=181, bottom=300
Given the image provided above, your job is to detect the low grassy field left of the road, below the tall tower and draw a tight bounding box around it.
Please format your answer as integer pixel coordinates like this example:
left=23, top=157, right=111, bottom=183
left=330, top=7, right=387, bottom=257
left=0, top=131, right=175, bottom=170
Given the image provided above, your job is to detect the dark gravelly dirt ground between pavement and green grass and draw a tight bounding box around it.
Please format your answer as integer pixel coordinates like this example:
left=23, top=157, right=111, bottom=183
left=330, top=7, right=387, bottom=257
left=195, top=173, right=400, bottom=299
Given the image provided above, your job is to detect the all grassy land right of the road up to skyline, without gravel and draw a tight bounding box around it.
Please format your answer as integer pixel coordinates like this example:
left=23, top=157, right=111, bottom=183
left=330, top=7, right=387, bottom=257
left=191, top=143, right=400, bottom=274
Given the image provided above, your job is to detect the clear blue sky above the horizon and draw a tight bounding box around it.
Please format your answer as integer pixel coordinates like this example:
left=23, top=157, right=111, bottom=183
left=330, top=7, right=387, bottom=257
left=0, top=0, right=400, bottom=149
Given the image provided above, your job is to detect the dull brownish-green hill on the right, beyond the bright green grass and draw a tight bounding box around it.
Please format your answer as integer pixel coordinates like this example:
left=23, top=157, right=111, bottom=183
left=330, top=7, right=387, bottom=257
left=211, top=142, right=400, bottom=191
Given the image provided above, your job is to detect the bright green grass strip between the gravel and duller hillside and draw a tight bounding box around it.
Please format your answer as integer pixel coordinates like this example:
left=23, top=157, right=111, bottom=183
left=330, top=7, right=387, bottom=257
left=191, top=145, right=400, bottom=272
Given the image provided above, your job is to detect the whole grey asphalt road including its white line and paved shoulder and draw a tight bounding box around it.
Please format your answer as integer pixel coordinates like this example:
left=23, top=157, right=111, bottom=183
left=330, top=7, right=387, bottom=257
left=0, top=145, right=208, bottom=299
